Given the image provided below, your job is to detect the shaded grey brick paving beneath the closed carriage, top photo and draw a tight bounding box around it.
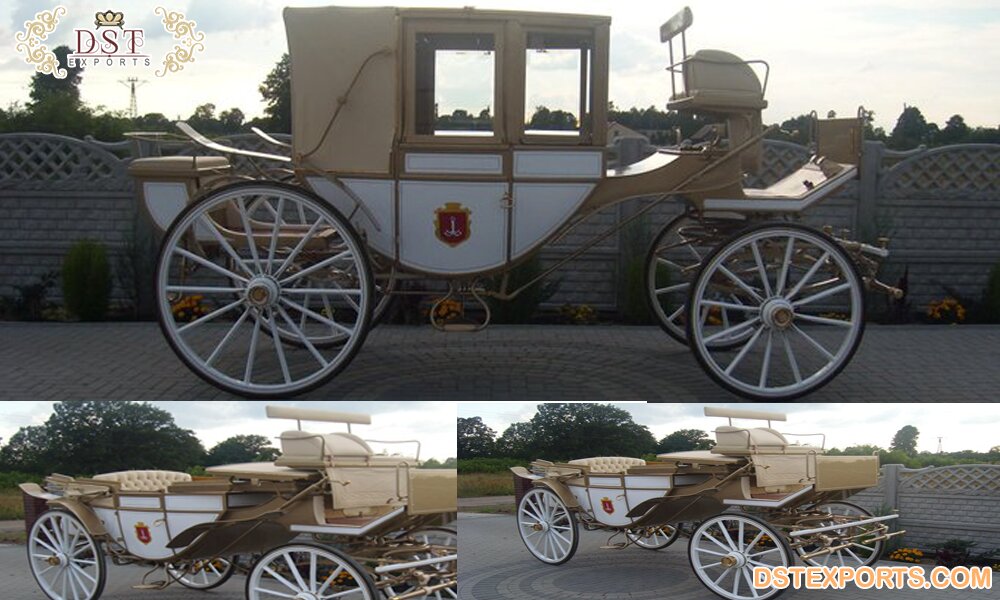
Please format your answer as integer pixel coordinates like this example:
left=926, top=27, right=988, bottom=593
left=0, top=323, right=1000, bottom=402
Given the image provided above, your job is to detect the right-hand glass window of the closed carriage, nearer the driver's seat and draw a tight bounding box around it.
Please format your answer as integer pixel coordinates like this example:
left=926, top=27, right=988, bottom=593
left=524, top=33, right=591, bottom=135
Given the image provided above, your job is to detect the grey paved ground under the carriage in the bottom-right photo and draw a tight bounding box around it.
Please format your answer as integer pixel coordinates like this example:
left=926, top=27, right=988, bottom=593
left=458, top=513, right=1000, bottom=600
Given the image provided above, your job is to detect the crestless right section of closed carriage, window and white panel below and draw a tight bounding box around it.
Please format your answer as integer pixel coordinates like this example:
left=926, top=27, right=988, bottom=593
left=511, top=28, right=607, bottom=259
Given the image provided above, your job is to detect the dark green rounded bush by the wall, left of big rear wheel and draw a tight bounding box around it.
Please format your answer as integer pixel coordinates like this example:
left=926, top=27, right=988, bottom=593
left=63, top=240, right=111, bottom=321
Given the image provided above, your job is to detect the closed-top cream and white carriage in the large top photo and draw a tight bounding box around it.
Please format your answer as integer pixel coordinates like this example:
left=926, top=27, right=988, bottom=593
left=130, top=7, right=896, bottom=398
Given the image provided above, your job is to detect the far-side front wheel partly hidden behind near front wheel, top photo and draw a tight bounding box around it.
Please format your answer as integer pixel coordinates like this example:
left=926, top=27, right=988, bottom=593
left=644, top=213, right=750, bottom=348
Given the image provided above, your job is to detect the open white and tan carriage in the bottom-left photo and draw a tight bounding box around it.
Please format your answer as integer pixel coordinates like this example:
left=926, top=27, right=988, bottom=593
left=21, top=406, right=458, bottom=600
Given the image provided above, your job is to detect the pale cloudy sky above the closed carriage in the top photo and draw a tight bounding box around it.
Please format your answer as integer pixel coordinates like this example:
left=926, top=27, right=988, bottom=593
left=0, top=0, right=1000, bottom=130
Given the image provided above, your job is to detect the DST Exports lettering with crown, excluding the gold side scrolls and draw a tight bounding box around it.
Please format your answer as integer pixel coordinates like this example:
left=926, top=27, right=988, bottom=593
left=72, top=10, right=152, bottom=67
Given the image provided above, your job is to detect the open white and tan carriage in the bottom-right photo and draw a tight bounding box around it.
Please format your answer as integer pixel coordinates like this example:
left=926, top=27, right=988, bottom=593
left=512, top=408, right=905, bottom=600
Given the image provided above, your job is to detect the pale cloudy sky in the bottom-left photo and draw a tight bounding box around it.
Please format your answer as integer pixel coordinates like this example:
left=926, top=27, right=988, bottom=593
left=0, top=400, right=457, bottom=461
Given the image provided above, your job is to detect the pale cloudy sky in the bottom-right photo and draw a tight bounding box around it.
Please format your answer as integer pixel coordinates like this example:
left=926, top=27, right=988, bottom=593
left=458, top=402, right=1000, bottom=458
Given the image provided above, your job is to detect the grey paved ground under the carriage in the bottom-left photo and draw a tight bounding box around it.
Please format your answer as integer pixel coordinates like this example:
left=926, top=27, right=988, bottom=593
left=0, top=544, right=246, bottom=600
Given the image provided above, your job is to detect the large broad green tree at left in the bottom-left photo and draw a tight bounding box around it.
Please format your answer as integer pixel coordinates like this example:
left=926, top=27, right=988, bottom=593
left=3, top=401, right=205, bottom=475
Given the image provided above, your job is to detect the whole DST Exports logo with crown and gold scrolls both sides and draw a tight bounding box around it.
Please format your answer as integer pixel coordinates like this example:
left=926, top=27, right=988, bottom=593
left=14, top=6, right=205, bottom=79
